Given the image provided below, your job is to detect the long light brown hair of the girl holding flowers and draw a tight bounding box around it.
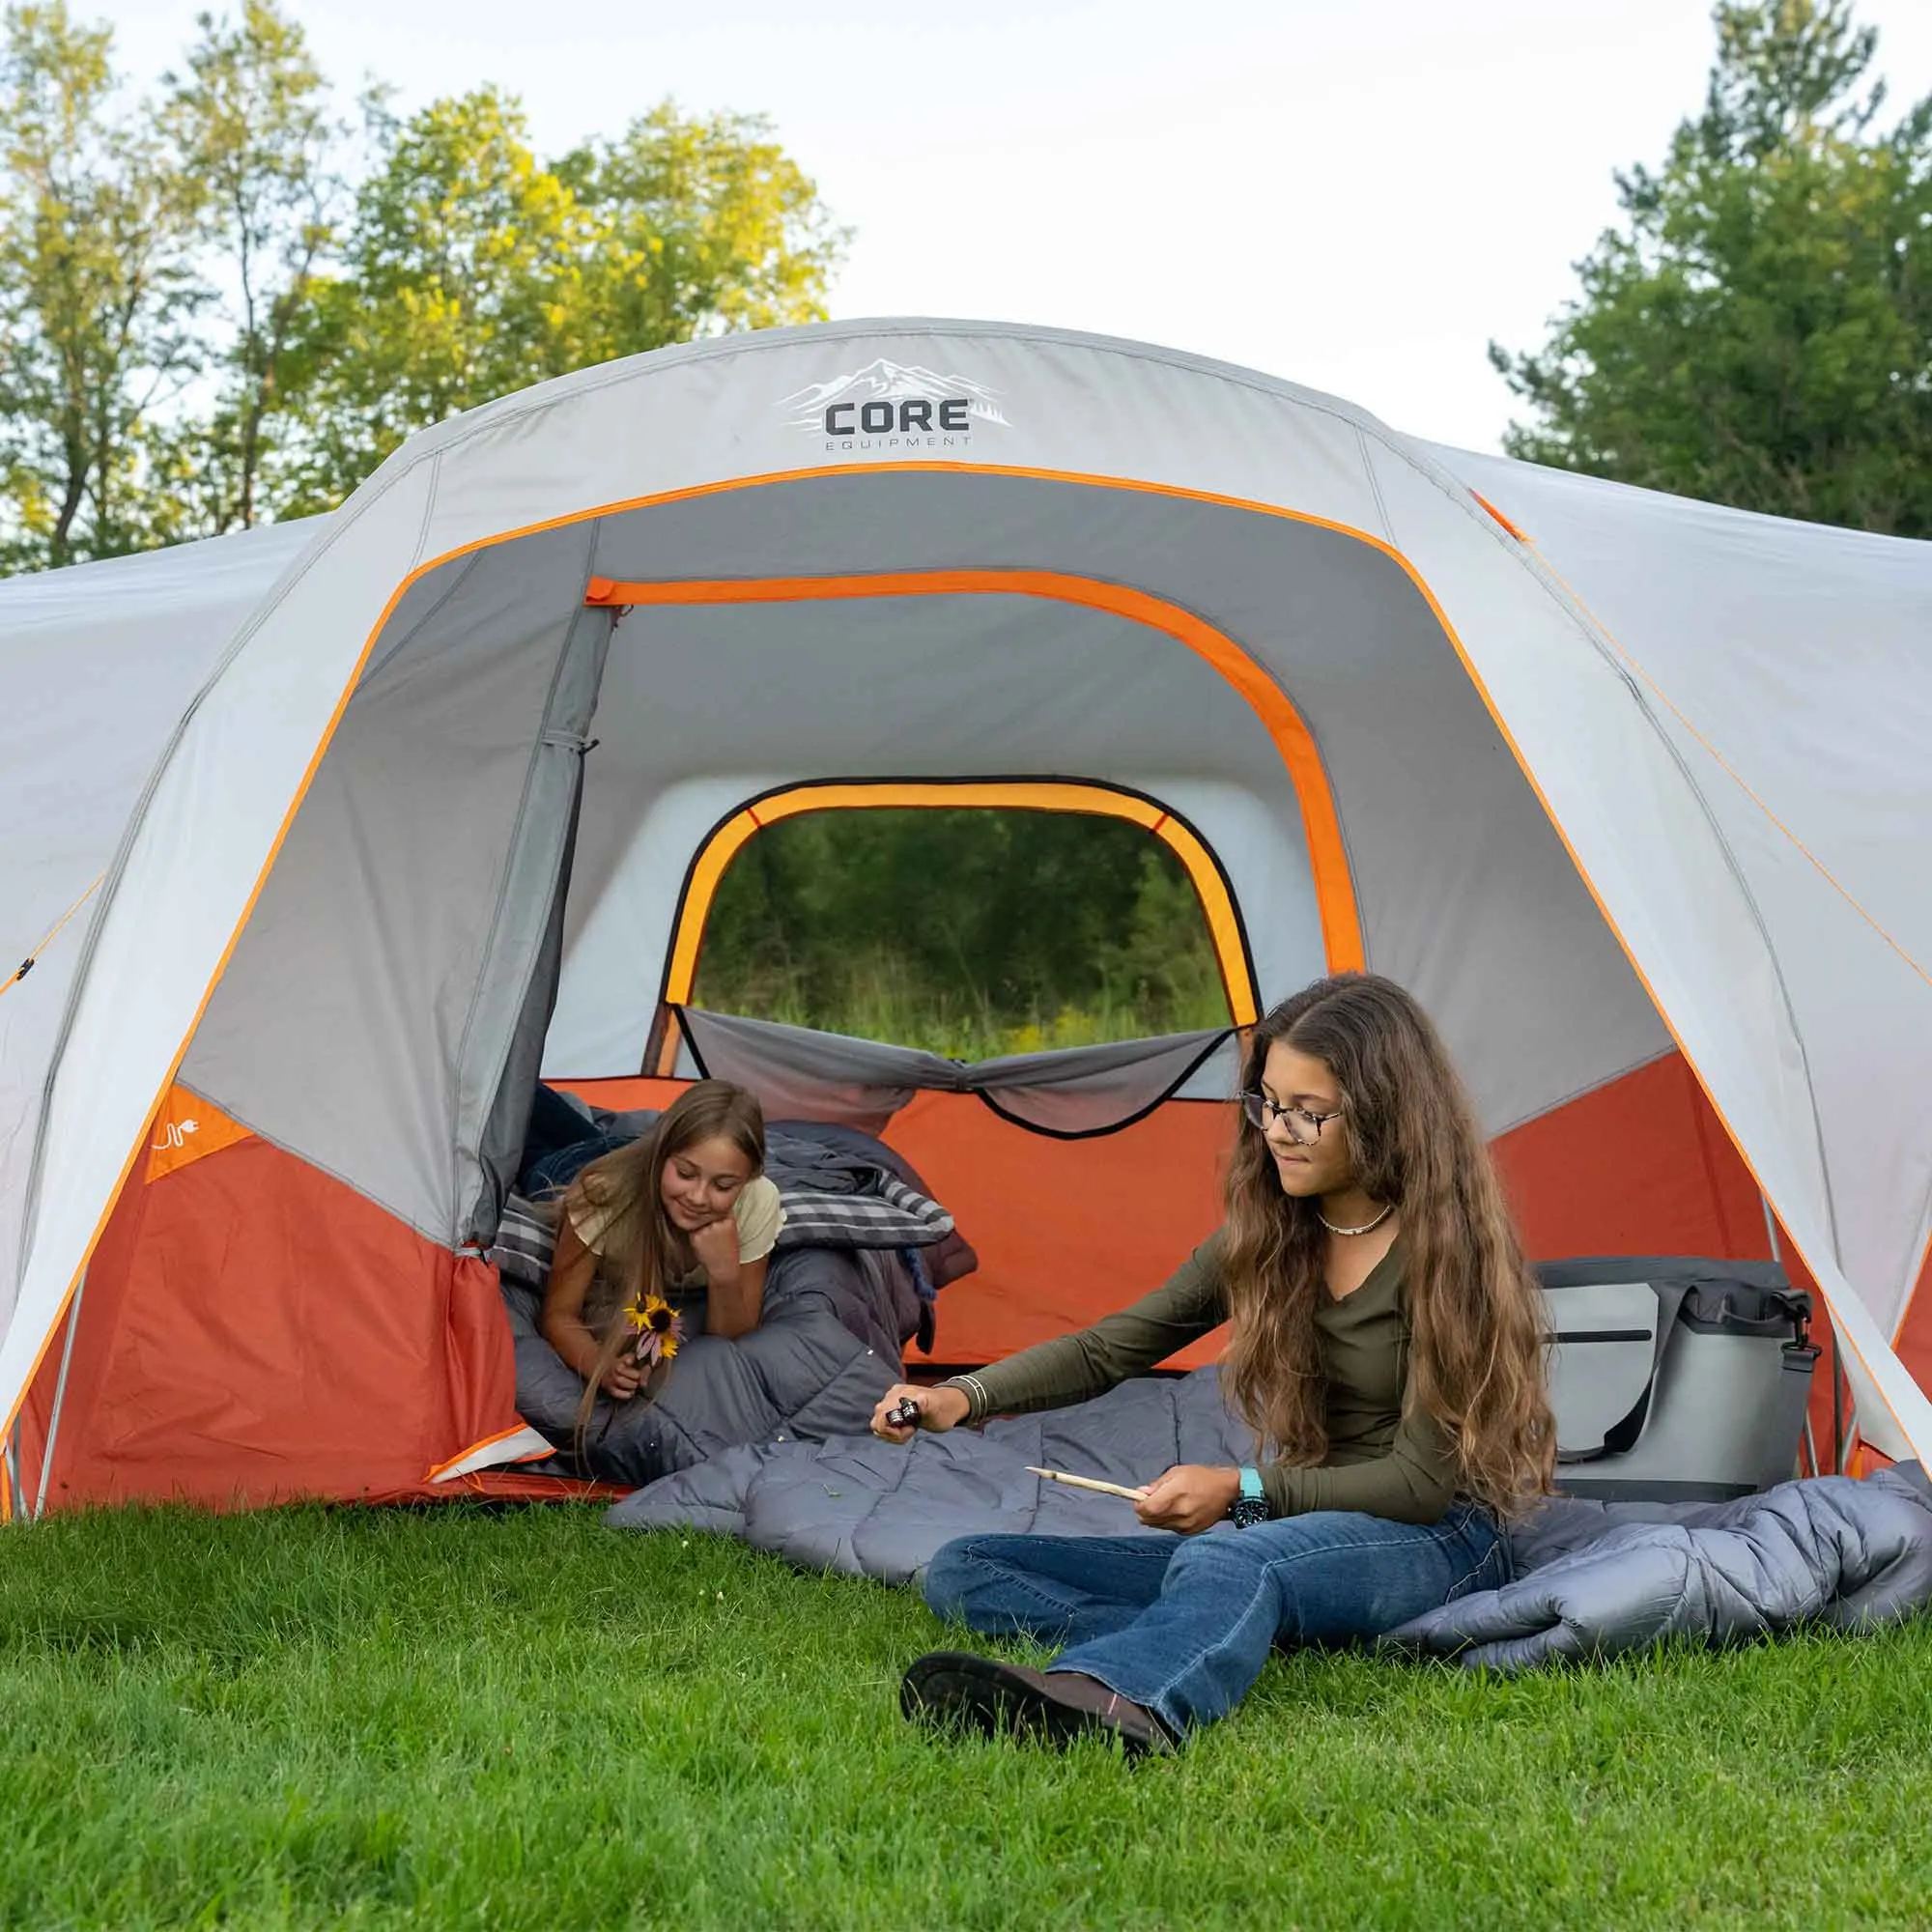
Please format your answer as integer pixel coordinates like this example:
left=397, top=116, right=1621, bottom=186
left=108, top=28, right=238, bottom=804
left=562, top=1080, right=765, bottom=1439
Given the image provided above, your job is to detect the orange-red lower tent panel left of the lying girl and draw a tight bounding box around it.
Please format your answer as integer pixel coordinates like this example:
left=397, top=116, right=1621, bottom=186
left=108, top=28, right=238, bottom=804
left=23, top=1140, right=518, bottom=1507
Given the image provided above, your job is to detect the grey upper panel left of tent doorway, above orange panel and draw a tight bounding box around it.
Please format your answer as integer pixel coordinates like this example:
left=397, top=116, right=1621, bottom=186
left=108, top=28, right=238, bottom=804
left=184, top=526, right=601, bottom=1242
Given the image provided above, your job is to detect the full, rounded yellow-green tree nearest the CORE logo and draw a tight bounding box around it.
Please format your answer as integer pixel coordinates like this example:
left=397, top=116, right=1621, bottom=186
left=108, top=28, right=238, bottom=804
left=288, top=89, right=842, bottom=508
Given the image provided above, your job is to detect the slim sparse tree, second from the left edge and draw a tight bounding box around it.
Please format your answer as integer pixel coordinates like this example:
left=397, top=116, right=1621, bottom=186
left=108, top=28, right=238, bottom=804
left=162, top=0, right=348, bottom=535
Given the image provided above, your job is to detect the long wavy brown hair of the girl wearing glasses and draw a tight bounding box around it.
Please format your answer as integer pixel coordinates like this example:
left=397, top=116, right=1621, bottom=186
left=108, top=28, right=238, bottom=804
left=1221, top=972, right=1555, bottom=1515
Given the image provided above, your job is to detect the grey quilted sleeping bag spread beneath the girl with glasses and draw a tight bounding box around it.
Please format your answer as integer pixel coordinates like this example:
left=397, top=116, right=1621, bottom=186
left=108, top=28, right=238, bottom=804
left=605, top=1368, right=1932, bottom=1669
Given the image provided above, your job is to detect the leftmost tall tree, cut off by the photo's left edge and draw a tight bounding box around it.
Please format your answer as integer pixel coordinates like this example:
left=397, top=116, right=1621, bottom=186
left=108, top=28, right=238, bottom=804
left=0, top=0, right=207, bottom=570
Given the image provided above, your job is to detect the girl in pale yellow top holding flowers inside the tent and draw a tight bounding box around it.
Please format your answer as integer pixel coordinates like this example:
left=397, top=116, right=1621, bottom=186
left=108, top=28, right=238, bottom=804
left=543, top=1080, right=784, bottom=1426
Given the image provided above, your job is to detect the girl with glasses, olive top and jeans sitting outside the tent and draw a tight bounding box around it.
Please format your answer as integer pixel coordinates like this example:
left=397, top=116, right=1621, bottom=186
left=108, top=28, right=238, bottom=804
left=871, top=974, right=1555, bottom=1750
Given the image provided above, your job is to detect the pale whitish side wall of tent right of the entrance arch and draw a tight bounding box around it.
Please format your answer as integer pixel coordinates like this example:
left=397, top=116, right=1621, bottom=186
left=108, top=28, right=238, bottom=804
left=1435, top=450, right=1932, bottom=1331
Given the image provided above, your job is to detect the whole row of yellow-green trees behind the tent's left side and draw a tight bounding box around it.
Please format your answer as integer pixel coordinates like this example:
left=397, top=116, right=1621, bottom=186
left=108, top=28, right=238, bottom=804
left=0, top=0, right=846, bottom=572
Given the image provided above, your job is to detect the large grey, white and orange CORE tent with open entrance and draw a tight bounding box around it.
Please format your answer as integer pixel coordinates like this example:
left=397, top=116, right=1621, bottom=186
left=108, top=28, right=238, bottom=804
left=0, top=321, right=1932, bottom=1507
